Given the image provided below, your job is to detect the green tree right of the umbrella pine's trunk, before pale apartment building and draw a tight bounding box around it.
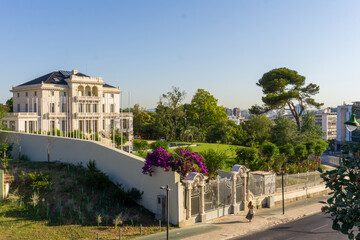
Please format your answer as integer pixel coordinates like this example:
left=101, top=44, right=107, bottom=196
left=301, top=112, right=323, bottom=141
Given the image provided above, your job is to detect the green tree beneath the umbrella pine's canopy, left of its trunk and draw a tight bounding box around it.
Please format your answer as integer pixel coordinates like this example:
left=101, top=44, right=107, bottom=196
left=270, top=114, right=299, bottom=146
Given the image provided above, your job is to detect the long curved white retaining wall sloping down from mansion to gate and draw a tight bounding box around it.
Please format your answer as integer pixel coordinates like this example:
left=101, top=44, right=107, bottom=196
left=0, top=131, right=184, bottom=225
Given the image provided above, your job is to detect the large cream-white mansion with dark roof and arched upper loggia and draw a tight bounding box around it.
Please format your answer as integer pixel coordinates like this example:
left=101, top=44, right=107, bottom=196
left=3, top=70, right=133, bottom=144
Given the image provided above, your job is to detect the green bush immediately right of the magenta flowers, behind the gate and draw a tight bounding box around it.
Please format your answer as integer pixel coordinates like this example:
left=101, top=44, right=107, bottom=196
left=200, top=149, right=227, bottom=178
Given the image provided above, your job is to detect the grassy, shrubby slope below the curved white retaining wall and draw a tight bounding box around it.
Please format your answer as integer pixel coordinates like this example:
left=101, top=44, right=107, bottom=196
left=0, top=161, right=173, bottom=240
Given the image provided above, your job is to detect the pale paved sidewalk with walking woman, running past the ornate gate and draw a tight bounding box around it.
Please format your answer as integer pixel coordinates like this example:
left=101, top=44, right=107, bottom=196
left=138, top=196, right=328, bottom=240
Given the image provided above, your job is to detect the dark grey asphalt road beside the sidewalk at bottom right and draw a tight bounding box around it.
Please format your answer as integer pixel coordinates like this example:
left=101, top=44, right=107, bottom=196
left=233, top=213, right=348, bottom=240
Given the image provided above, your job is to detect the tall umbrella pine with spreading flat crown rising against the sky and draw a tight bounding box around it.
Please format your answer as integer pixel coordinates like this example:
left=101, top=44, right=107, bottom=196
left=250, top=68, right=323, bottom=132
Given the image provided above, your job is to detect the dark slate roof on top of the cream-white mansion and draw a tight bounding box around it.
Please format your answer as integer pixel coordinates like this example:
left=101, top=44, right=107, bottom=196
left=19, top=70, right=89, bottom=86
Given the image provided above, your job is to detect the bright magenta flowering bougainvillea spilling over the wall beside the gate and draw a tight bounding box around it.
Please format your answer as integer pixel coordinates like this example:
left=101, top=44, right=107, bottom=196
left=142, top=148, right=208, bottom=178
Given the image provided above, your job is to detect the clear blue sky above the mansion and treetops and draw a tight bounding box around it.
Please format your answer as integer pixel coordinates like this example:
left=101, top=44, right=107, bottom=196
left=0, top=0, right=360, bottom=109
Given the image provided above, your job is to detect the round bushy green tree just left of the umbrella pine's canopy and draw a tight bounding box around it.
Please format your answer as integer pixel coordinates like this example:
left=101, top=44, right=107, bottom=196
left=244, top=115, right=273, bottom=146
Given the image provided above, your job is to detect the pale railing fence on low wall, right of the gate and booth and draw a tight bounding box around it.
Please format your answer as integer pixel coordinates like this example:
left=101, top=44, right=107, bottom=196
left=276, top=172, right=323, bottom=192
